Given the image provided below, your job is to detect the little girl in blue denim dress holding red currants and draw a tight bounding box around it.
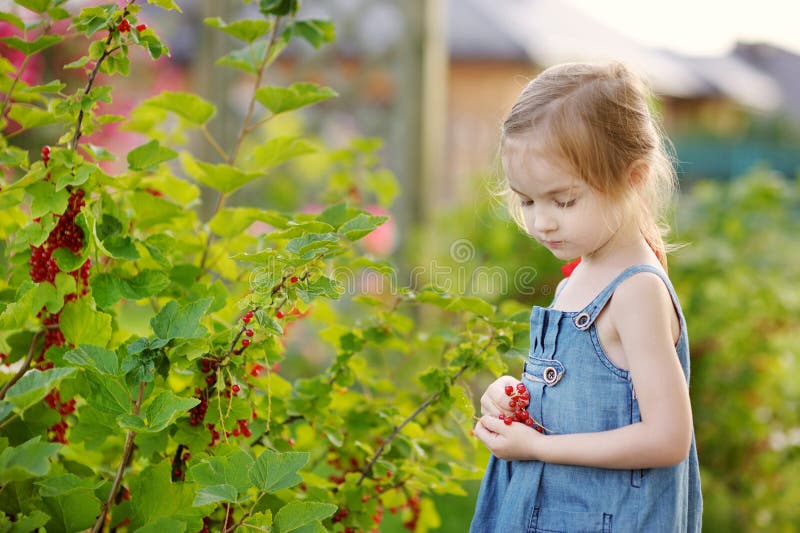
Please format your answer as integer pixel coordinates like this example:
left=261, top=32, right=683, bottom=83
left=470, top=63, right=702, bottom=533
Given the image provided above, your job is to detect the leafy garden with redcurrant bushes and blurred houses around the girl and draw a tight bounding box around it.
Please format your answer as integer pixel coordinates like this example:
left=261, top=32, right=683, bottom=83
left=0, top=0, right=800, bottom=532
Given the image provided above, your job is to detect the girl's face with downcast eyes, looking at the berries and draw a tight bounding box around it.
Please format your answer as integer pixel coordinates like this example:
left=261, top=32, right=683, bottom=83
left=503, top=139, right=622, bottom=261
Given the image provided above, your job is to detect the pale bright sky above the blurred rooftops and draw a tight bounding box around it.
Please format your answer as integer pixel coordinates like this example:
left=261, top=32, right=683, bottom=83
left=564, top=0, right=800, bottom=56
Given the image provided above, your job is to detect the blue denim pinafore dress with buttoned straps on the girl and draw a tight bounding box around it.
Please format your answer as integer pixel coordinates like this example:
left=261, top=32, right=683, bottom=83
left=470, top=265, right=703, bottom=533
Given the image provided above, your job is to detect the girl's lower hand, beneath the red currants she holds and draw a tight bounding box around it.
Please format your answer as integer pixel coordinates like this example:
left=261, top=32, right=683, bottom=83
left=474, top=414, right=546, bottom=461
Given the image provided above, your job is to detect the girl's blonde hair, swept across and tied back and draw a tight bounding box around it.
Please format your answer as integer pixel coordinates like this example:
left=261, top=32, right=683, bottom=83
left=500, top=62, right=677, bottom=269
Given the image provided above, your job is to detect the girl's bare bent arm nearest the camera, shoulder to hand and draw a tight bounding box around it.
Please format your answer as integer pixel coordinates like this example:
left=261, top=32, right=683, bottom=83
left=475, top=274, right=692, bottom=469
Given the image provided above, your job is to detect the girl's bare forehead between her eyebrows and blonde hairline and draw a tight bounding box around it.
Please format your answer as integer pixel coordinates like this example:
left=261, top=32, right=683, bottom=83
left=502, top=138, right=584, bottom=195
